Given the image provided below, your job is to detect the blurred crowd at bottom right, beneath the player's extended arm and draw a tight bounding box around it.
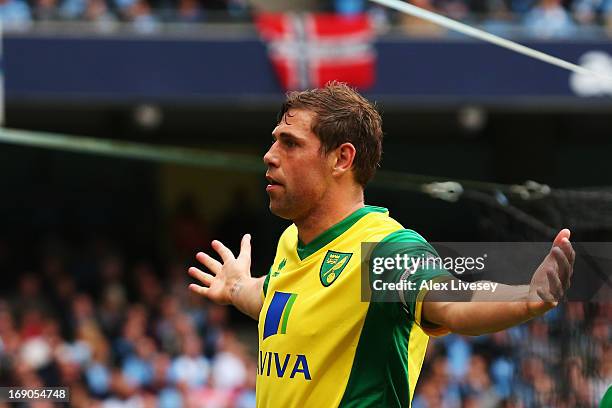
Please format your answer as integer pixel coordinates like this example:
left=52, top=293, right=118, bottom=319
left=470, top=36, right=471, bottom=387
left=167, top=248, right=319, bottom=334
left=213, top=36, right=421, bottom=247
left=412, top=302, right=612, bottom=408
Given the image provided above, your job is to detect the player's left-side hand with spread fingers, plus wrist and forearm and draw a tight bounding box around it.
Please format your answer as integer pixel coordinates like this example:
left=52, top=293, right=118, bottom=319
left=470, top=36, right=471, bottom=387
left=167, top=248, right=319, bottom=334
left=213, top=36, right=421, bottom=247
left=189, top=234, right=265, bottom=320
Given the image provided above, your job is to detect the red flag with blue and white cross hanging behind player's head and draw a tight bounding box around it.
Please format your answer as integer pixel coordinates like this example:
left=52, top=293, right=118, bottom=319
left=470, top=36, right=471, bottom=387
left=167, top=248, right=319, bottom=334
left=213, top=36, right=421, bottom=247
left=256, top=13, right=376, bottom=90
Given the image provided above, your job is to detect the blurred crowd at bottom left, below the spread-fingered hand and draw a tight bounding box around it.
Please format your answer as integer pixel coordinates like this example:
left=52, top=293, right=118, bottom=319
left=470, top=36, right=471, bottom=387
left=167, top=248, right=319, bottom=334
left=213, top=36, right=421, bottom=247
left=0, top=270, right=255, bottom=408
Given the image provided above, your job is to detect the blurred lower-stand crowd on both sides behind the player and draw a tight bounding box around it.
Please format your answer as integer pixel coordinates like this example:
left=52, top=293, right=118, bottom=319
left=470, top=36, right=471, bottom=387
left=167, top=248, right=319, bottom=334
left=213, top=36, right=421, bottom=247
left=0, top=193, right=612, bottom=408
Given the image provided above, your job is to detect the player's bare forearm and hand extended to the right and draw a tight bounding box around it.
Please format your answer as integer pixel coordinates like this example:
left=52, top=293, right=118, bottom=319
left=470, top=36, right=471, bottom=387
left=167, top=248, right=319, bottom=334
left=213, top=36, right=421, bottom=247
left=422, top=229, right=576, bottom=336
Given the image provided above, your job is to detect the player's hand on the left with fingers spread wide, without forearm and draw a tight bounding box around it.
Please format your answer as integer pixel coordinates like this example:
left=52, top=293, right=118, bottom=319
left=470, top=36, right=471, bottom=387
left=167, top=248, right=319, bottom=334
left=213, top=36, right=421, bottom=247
left=188, top=234, right=251, bottom=305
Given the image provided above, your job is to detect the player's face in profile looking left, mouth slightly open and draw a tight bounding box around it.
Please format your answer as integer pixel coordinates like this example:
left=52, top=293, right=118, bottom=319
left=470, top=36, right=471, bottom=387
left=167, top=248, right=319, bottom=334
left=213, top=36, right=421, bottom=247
left=263, top=109, right=331, bottom=220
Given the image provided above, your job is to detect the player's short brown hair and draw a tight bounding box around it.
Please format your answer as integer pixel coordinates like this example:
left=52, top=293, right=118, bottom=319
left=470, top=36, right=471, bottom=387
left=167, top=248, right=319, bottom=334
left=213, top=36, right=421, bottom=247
left=278, top=81, right=383, bottom=187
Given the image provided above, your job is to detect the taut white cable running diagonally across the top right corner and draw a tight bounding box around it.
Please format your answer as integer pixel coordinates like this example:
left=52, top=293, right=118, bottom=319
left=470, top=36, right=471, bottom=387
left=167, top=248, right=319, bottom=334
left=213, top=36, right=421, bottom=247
left=370, top=0, right=612, bottom=81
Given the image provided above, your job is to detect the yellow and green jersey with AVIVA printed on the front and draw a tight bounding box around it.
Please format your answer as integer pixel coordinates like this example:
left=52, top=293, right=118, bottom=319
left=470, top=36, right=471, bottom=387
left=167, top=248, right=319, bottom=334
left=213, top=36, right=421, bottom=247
left=256, top=206, right=450, bottom=408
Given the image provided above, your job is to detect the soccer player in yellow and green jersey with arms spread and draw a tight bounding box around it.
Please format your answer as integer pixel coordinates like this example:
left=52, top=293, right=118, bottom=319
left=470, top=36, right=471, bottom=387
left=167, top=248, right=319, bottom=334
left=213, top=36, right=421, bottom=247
left=189, top=83, right=575, bottom=408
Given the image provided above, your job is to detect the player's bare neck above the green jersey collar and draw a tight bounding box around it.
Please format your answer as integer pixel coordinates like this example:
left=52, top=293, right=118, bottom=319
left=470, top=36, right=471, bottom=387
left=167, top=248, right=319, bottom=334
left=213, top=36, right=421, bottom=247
left=294, top=194, right=364, bottom=244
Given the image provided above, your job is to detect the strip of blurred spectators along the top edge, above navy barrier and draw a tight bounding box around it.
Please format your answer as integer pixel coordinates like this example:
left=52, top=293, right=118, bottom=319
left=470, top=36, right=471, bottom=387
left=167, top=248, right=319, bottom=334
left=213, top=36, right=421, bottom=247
left=0, top=0, right=612, bottom=38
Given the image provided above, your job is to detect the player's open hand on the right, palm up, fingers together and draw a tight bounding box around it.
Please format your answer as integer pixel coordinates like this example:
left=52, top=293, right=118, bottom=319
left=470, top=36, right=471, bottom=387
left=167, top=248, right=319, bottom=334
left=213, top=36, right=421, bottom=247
left=528, top=229, right=576, bottom=316
